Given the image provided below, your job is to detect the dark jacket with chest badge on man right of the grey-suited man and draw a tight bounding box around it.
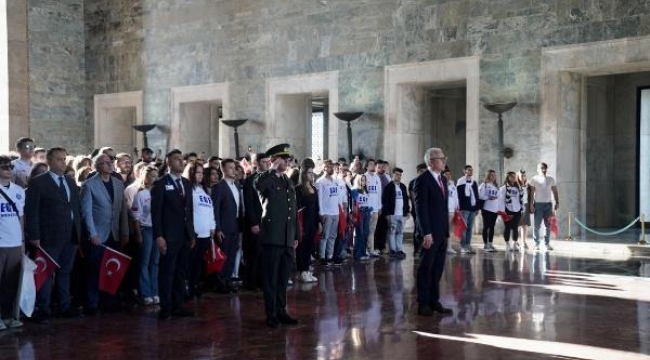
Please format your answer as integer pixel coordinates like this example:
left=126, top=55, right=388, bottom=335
left=151, top=174, right=196, bottom=242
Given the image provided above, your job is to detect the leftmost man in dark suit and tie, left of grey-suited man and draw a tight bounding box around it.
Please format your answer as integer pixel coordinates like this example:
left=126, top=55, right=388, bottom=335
left=25, top=147, right=81, bottom=322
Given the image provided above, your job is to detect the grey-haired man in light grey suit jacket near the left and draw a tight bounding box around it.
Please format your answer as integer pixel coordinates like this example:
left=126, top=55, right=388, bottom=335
left=81, top=154, right=129, bottom=315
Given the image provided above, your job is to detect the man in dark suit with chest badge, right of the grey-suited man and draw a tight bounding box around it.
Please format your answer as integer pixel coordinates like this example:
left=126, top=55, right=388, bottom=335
left=151, top=149, right=195, bottom=320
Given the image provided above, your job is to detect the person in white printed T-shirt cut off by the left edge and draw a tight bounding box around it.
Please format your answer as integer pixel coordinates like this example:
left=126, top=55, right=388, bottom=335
left=0, top=156, right=25, bottom=330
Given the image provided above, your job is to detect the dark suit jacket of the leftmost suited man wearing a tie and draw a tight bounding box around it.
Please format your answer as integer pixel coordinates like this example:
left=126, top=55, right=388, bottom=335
left=25, top=172, right=81, bottom=246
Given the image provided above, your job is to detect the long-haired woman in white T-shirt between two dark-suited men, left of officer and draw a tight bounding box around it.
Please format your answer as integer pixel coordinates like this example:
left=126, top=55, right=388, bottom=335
left=183, top=161, right=216, bottom=298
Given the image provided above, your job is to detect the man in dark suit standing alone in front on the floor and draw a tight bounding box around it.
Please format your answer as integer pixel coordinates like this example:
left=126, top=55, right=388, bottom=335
left=414, top=148, right=452, bottom=316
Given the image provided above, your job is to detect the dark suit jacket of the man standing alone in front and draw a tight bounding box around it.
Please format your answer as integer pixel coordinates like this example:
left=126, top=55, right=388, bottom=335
left=414, top=170, right=449, bottom=243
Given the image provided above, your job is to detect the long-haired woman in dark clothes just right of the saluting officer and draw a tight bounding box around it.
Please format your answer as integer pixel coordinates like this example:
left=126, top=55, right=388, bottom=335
left=296, top=167, right=321, bottom=283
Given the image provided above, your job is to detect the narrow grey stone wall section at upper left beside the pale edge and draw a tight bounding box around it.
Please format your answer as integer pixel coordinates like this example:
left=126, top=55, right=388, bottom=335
left=28, top=0, right=86, bottom=153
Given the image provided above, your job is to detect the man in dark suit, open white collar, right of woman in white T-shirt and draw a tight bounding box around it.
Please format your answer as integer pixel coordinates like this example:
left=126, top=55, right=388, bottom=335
left=212, top=159, right=244, bottom=292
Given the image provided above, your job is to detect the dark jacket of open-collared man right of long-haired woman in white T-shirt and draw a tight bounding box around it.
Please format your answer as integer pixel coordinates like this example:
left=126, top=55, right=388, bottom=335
left=211, top=180, right=244, bottom=234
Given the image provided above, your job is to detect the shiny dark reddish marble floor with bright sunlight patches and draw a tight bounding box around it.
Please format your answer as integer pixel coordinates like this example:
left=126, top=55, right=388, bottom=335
left=0, top=248, right=650, bottom=360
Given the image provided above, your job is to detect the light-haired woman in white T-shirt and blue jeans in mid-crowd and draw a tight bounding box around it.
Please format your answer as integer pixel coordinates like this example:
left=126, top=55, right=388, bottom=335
left=350, top=174, right=372, bottom=260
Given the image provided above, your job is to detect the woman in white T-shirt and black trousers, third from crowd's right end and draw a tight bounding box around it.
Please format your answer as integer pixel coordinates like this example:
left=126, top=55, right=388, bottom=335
left=499, top=171, right=524, bottom=251
